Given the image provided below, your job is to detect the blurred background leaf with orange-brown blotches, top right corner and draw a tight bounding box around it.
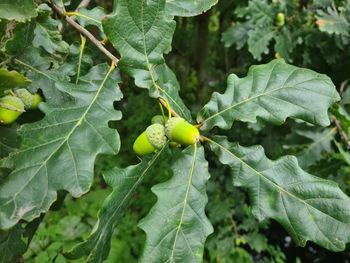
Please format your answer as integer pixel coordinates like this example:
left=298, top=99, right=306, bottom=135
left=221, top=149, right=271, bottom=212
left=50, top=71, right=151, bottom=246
left=316, top=7, right=350, bottom=36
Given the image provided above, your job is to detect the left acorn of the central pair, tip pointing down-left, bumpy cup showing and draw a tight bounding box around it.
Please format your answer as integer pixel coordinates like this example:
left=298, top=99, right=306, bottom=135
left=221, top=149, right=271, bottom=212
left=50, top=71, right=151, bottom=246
left=133, top=123, right=167, bottom=156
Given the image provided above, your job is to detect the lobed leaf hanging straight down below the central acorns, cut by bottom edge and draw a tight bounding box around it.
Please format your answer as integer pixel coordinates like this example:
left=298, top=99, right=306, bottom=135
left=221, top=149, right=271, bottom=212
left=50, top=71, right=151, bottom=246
left=140, top=146, right=213, bottom=263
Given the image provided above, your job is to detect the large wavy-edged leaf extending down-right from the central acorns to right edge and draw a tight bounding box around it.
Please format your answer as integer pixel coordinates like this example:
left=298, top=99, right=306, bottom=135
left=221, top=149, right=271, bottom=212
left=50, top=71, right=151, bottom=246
left=210, top=136, right=350, bottom=251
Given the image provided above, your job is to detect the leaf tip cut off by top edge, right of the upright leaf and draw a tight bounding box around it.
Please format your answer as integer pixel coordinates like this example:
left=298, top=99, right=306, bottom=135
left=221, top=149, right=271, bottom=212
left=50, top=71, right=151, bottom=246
left=166, top=0, right=218, bottom=16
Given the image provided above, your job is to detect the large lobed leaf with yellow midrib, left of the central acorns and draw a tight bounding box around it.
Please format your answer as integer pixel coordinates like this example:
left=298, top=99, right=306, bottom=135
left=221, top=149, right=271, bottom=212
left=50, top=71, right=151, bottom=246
left=0, top=64, right=122, bottom=229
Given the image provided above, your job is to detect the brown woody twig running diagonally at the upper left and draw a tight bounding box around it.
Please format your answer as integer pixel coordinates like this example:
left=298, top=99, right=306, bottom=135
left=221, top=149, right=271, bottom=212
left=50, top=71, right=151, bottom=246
left=52, top=4, right=119, bottom=65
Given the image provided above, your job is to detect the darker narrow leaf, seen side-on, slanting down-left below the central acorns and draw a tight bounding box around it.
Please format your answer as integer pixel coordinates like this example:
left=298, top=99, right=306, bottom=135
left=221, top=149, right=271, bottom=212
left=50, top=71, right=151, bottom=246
left=65, top=148, right=165, bottom=263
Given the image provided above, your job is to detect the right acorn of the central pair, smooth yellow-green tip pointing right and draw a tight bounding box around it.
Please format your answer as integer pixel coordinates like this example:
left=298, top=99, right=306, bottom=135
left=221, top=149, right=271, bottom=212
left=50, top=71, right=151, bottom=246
left=165, top=117, right=200, bottom=146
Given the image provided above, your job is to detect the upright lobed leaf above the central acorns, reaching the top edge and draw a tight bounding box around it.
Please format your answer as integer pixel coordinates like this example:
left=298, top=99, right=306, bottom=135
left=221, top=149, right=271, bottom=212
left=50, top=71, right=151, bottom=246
left=103, top=0, right=191, bottom=120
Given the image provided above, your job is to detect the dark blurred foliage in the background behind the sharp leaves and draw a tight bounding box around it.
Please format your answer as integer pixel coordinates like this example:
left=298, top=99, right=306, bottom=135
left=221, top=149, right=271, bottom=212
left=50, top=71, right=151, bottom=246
left=17, top=0, right=350, bottom=263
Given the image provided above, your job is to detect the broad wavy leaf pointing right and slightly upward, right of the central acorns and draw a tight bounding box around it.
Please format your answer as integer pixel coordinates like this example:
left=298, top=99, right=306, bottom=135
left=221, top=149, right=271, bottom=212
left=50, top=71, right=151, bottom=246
left=197, top=59, right=340, bottom=130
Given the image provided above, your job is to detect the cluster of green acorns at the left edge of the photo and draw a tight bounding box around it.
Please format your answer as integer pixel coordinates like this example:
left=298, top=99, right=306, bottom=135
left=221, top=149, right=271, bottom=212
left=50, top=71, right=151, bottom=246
left=0, top=89, right=42, bottom=124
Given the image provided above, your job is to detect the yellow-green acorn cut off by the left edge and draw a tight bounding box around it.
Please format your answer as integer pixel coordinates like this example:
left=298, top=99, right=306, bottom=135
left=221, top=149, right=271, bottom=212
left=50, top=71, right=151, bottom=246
left=0, top=95, right=24, bottom=124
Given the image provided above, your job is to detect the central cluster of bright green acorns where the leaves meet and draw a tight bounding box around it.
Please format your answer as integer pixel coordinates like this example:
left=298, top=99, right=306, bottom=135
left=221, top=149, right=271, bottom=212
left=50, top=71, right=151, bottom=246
left=133, top=115, right=200, bottom=156
